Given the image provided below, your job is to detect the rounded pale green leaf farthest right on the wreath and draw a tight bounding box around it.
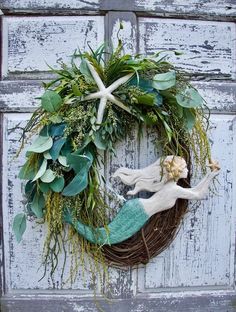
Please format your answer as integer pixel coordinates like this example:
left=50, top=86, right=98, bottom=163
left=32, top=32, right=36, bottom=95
left=176, top=87, right=203, bottom=108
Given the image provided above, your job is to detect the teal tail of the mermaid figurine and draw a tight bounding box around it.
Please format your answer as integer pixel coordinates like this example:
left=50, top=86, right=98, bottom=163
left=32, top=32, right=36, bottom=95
left=64, top=198, right=149, bottom=245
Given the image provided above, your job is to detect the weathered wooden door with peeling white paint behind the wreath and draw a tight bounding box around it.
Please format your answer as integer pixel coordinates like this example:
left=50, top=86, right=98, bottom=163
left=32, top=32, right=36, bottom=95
left=0, top=0, right=236, bottom=312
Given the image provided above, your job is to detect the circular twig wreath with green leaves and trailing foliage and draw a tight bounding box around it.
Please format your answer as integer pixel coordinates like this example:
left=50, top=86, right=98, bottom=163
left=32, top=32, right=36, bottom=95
left=13, top=42, right=210, bottom=278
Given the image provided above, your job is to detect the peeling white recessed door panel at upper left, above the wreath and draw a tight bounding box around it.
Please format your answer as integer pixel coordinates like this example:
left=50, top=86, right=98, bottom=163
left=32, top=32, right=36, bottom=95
left=3, top=16, right=104, bottom=76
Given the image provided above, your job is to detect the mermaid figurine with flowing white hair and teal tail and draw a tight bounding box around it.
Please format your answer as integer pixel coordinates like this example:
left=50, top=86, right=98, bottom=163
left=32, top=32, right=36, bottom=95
left=65, top=155, right=220, bottom=245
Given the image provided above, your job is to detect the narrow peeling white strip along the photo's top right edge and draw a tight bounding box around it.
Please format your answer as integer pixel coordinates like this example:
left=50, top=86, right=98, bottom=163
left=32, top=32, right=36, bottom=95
left=134, top=0, right=236, bottom=16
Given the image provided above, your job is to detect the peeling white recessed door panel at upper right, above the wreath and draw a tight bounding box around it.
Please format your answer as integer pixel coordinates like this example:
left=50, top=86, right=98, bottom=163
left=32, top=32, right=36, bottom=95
left=139, top=18, right=235, bottom=77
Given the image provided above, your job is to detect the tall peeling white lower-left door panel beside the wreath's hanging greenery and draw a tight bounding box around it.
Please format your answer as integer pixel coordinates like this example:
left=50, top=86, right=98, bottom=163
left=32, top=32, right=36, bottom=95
left=3, top=114, right=97, bottom=294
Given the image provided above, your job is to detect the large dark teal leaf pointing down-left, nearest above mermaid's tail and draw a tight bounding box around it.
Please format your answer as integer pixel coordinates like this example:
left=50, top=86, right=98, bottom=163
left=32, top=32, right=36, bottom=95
left=62, top=171, right=88, bottom=196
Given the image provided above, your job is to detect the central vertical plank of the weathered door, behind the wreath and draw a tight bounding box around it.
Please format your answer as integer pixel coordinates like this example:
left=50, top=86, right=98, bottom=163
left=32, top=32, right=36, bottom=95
left=105, top=12, right=138, bottom=298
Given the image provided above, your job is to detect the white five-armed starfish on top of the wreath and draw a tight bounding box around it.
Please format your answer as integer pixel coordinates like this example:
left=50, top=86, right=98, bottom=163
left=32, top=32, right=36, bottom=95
left=84, top=61, right=133, bottom=125
